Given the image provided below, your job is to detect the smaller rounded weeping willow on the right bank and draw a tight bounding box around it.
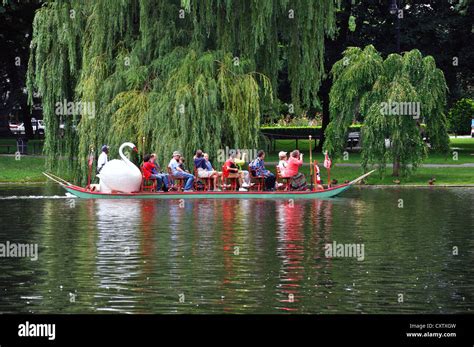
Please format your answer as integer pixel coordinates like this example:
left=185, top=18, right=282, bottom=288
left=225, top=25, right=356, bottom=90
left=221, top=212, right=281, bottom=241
left=325, top=45, right=449, bottom=176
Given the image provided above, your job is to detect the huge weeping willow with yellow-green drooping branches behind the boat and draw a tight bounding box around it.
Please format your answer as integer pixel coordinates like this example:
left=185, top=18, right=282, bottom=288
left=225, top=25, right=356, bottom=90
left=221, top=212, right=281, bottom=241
left=28, top=0, right=335, bottom=185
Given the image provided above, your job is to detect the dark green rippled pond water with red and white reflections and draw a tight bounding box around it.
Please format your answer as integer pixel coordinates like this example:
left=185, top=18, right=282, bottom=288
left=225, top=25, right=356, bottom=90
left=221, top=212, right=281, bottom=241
left=0, top=184, right=474, bottom=314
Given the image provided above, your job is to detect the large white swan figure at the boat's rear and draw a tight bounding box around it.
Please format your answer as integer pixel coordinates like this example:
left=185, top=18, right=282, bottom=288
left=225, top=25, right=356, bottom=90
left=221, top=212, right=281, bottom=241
left=97, top=142, right=142, bottom=193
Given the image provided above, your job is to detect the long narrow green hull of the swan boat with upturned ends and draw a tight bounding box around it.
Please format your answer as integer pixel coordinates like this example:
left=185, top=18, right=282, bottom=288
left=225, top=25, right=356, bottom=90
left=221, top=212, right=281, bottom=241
left=43, top=170, right=375, bottom=199
